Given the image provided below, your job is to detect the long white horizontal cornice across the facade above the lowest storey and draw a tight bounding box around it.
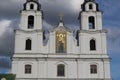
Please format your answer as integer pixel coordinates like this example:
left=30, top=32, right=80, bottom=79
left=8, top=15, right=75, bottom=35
left=13, top=53, right=111, bottom=59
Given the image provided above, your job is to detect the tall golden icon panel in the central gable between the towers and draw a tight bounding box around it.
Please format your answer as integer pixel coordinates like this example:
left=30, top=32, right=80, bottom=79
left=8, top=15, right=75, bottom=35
left=56, top=31, right=66, bottom=53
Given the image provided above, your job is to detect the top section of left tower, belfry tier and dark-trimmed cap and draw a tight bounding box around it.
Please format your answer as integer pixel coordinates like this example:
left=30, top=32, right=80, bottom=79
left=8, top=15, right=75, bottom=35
left=20, top=0, right=43, bottom=30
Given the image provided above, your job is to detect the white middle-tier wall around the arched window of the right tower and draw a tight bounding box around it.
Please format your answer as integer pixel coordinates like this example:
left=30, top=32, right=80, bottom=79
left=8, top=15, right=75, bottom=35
left=79, top=30, right=107, bottom=54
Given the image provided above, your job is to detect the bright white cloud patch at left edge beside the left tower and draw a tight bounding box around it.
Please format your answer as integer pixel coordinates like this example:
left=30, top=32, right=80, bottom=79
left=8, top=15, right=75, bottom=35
left=0, top=20, right=11, bottom=36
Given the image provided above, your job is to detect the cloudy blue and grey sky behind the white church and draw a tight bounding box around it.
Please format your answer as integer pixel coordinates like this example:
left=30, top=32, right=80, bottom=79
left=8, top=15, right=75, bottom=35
left=0, top=0, right=120, bottom=80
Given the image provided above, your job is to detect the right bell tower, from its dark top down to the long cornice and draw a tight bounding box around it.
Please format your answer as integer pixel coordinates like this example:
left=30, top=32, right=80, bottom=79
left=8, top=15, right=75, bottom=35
left=78, top=0, right=107, bottom=54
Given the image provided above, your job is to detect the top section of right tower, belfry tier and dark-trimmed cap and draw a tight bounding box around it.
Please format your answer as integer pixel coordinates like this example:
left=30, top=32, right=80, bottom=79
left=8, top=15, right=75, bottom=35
left=79, top=0, right=102, bottom=30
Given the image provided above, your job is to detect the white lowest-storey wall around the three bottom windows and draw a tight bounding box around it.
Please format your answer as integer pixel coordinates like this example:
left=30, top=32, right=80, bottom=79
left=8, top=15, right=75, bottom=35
left=12, top=57, right=110, bottom=78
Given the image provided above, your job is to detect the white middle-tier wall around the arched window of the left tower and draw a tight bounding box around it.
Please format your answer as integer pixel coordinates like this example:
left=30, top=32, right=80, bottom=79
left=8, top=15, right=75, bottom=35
left=15, top=30, right=43, bottom=53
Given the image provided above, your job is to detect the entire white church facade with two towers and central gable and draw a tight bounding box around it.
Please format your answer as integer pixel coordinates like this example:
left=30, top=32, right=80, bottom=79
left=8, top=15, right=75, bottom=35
left=12, top=0, right=111, bottom=80
